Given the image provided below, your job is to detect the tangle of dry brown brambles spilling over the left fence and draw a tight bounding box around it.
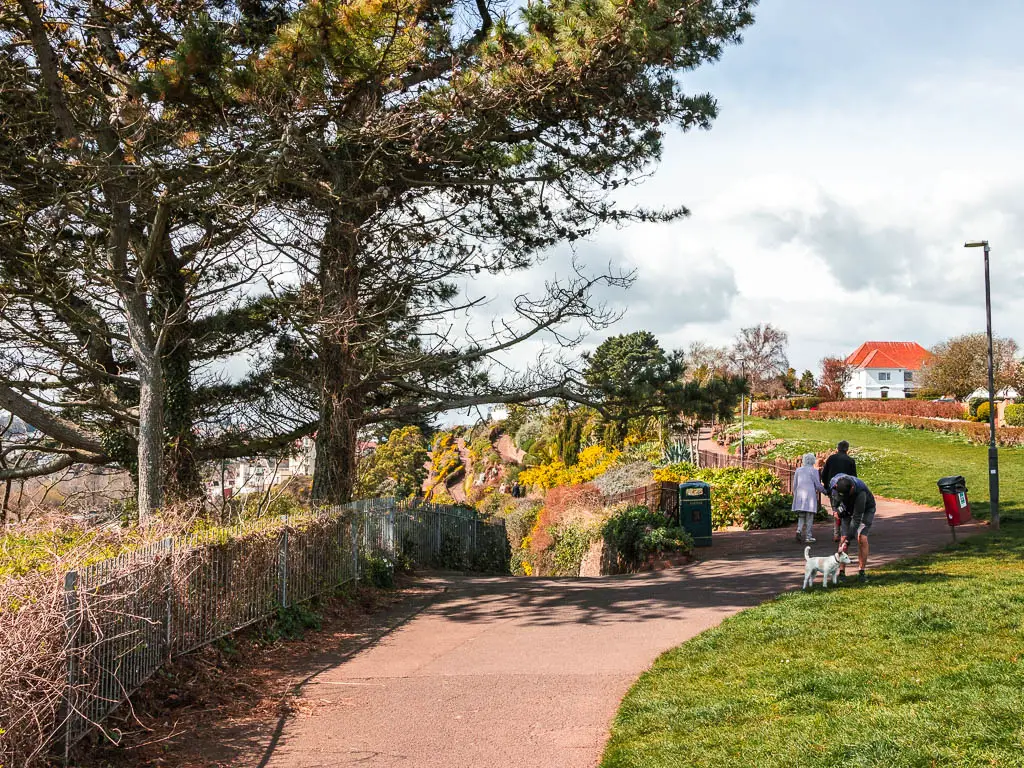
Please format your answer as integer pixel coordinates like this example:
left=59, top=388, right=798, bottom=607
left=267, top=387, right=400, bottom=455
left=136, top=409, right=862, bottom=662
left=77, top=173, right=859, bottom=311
left=0, top=507, right=344, bottom=768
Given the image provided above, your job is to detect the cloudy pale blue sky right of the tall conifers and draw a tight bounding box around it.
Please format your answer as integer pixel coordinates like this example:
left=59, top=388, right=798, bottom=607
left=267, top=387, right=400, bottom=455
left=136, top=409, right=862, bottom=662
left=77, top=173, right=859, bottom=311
left=466, top=0, right=1024, bottom=385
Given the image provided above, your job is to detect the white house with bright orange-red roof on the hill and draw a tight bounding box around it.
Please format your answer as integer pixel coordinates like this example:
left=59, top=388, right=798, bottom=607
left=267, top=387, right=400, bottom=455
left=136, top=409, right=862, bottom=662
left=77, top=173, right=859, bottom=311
left=843, top=341, right=932, bottom=398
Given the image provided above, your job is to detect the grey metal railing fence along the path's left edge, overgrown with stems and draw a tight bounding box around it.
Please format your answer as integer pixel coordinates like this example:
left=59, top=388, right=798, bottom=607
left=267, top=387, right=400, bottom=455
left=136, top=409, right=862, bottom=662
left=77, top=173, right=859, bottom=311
left=62, top=499, right=509, bottom=752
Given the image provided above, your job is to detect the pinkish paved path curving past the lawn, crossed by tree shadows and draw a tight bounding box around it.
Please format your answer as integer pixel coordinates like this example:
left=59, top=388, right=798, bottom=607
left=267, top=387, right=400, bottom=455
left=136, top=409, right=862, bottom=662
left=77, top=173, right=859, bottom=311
left=262, top=500, right=980, bottom=768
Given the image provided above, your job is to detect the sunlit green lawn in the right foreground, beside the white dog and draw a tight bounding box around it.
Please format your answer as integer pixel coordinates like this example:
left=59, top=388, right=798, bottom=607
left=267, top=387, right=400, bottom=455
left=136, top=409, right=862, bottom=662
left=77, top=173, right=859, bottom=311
left=601, top=528, right=1024, bottom=768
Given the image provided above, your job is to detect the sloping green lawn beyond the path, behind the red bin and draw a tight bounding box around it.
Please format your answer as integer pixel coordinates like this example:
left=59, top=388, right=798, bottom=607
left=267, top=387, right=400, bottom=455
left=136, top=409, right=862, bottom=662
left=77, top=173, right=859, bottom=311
left=749, top=419, right=1024, bottom=519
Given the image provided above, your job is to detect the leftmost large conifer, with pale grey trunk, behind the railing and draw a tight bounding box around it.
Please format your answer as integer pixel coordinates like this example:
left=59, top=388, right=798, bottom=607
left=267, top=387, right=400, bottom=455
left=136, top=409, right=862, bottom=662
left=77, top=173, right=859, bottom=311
left=0, top=0, right=282, bottom=516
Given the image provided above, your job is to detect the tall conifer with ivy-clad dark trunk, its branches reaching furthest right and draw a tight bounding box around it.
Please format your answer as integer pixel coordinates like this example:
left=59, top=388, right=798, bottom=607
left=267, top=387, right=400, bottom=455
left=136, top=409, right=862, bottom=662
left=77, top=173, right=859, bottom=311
left=252, top=0, right=754, bottom=502
